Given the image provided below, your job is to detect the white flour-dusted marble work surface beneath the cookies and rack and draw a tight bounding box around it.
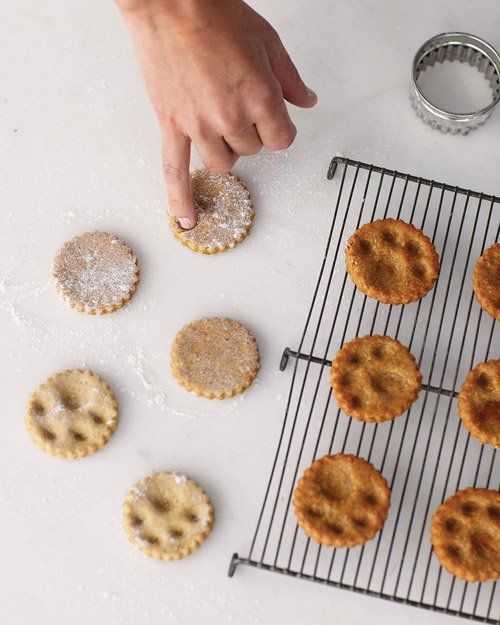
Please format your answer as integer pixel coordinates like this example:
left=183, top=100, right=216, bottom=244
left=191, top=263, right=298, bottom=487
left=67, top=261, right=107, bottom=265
left=0, top=0, right=500, bottom=625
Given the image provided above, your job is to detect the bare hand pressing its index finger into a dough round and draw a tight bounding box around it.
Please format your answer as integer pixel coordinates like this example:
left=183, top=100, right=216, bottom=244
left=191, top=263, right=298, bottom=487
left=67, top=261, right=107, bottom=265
left=116, top=0, right=317, bottom=229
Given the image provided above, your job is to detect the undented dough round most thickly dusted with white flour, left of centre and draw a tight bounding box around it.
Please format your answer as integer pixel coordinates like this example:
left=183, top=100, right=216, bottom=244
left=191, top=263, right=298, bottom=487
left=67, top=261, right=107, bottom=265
left=52, top=232, right=139, bottom=315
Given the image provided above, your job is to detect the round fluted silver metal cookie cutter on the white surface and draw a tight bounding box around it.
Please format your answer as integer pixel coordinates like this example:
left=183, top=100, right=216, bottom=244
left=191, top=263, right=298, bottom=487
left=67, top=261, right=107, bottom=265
left=410, top=32, right=500, bottom=134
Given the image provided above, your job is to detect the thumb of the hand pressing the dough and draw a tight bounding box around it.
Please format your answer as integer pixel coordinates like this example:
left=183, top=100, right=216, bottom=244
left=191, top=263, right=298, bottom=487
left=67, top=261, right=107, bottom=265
left=267, top=38, right=318, bottom=108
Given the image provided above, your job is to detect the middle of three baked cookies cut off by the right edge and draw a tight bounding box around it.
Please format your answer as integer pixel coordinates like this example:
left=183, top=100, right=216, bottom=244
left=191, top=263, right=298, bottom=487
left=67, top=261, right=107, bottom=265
left=458, top=360, right=500, bottom=447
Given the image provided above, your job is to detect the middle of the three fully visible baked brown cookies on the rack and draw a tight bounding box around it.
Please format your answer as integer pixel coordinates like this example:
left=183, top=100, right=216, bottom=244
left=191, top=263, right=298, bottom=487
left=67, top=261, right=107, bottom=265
left=331, top=334, right=422, bottom=421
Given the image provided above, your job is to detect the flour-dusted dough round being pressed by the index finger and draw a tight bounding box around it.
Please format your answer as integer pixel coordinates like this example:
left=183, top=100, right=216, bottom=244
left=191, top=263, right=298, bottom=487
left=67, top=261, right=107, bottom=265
left=169, top=169, right=254, bottom=254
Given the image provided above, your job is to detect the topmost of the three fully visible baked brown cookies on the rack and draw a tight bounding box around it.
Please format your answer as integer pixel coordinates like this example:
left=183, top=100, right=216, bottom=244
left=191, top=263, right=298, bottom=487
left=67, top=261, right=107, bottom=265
left=346, top=219, right=439, bottom=304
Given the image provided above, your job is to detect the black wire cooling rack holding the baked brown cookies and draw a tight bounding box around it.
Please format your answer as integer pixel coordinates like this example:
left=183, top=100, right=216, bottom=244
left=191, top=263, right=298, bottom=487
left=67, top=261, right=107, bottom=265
left=229, top=157, right=500, bottom=623
